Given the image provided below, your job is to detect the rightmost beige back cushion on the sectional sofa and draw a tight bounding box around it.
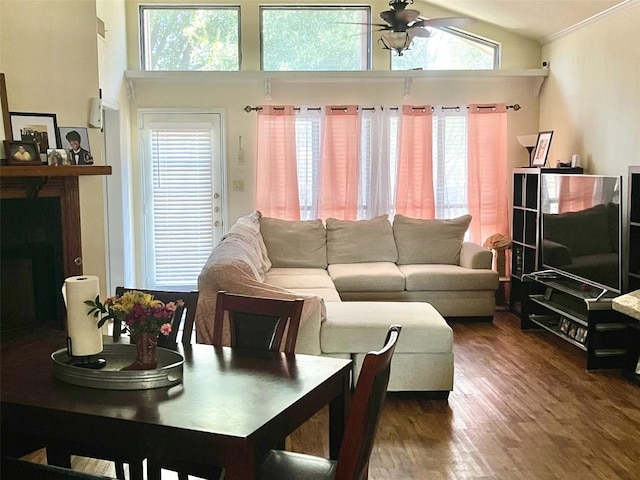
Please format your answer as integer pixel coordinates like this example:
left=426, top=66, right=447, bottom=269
left=393, top=214, right=471, bottom=265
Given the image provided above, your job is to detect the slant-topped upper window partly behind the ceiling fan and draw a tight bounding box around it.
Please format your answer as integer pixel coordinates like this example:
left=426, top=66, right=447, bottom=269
left=391, top=27, right=500, bottom=70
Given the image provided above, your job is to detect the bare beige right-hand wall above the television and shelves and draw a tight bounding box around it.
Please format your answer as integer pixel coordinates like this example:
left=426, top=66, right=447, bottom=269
left=540, top=3, right=640, bottom=175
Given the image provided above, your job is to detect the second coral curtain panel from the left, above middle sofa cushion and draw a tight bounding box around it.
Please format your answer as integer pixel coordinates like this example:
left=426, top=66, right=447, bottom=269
left=318, top=105, right=360, bottom=220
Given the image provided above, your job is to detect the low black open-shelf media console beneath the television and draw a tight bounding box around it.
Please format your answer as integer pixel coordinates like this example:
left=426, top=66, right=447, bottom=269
left=520, top=270, right=627, bottom=370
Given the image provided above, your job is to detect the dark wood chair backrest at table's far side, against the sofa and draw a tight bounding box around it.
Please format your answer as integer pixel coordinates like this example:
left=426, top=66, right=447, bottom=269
left=213, top=291, right=304, bottom=353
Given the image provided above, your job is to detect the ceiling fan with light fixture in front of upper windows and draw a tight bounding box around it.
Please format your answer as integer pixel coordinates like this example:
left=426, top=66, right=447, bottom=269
left=371, top=0, right=471, bottom=56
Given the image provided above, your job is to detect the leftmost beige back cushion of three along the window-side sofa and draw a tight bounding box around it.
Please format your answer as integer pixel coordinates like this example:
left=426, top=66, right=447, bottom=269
left=260, top=217, right=327, bottom=268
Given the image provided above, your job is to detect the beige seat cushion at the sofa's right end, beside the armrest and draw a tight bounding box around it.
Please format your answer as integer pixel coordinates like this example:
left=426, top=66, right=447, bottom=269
left=398, top=264, right=499, bottom=290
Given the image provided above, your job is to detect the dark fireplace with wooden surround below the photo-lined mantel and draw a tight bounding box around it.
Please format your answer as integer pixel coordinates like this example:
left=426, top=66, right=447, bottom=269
left=0, top=172, right=90, bottom=343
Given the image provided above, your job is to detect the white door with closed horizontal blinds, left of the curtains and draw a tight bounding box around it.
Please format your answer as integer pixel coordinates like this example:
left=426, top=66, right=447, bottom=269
left=138, top=110, right=225, bottom=290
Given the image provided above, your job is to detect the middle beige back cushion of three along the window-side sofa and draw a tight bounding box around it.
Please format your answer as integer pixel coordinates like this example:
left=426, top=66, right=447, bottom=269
left=327, top=215, right=398, bottom=264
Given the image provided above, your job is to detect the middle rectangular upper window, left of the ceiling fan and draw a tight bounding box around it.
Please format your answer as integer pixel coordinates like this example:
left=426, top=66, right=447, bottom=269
left=260, top=6, right=371, bottom=71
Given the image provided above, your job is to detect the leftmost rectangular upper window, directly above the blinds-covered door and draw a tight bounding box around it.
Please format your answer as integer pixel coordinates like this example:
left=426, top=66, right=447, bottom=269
left=140, top=6, right=240, bottom=71
